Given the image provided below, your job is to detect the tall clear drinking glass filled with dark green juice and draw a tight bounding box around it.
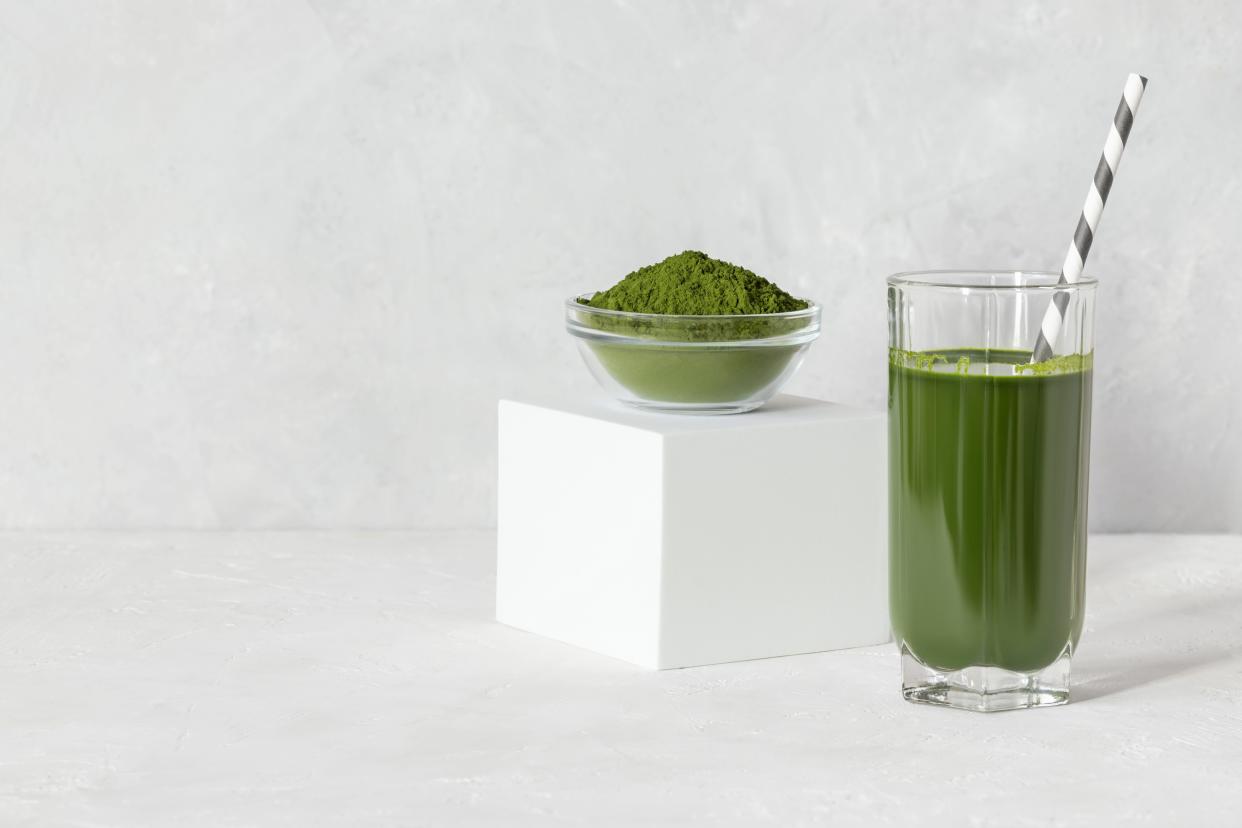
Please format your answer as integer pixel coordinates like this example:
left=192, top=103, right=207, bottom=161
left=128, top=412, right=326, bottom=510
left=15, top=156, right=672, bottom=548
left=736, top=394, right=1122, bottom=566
left=888, top=271, right=1095, bottom=711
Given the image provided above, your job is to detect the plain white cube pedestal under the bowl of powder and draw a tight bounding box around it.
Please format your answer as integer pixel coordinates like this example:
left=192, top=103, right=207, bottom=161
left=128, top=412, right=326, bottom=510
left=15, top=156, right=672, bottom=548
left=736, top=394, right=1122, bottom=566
left=496, top=396, right=889, bottom=669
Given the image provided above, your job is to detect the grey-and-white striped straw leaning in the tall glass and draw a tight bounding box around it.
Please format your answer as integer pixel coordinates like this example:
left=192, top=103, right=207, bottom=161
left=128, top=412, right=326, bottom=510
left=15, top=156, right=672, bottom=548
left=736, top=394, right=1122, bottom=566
left=1031, top=74, right=1148, bottom=362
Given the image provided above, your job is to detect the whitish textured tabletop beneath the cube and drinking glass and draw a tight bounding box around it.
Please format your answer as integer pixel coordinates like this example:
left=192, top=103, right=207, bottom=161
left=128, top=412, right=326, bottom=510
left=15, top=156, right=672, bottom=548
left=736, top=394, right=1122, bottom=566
left=0, top=533, right=1242, bottom=828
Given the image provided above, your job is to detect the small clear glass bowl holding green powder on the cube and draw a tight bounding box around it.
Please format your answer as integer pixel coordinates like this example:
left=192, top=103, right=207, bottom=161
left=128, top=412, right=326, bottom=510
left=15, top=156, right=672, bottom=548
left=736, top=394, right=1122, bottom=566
left=565, top=293, right=820, bottom=413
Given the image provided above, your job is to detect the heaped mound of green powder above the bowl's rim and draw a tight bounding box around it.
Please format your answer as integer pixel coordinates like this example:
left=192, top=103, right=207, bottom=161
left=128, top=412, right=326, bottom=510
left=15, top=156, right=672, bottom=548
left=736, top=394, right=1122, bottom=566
left=584, top=251, right=807, bottom=315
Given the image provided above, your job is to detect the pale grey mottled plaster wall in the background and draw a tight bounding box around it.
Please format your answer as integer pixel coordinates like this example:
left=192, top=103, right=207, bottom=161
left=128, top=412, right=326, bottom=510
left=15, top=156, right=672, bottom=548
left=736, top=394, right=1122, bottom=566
left=0, top=0, right=1242, bottom=530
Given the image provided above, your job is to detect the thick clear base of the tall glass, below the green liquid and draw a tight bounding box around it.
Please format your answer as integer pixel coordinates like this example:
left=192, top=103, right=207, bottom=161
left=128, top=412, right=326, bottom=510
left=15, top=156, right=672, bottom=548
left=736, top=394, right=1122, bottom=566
left=902, top=644, right=1071, bottom=713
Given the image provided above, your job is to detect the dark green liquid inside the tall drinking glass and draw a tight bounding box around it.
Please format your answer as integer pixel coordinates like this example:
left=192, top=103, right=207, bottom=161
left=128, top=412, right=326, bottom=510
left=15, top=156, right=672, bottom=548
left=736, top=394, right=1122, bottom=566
left=888, top=349, right=1092, bottom=673
